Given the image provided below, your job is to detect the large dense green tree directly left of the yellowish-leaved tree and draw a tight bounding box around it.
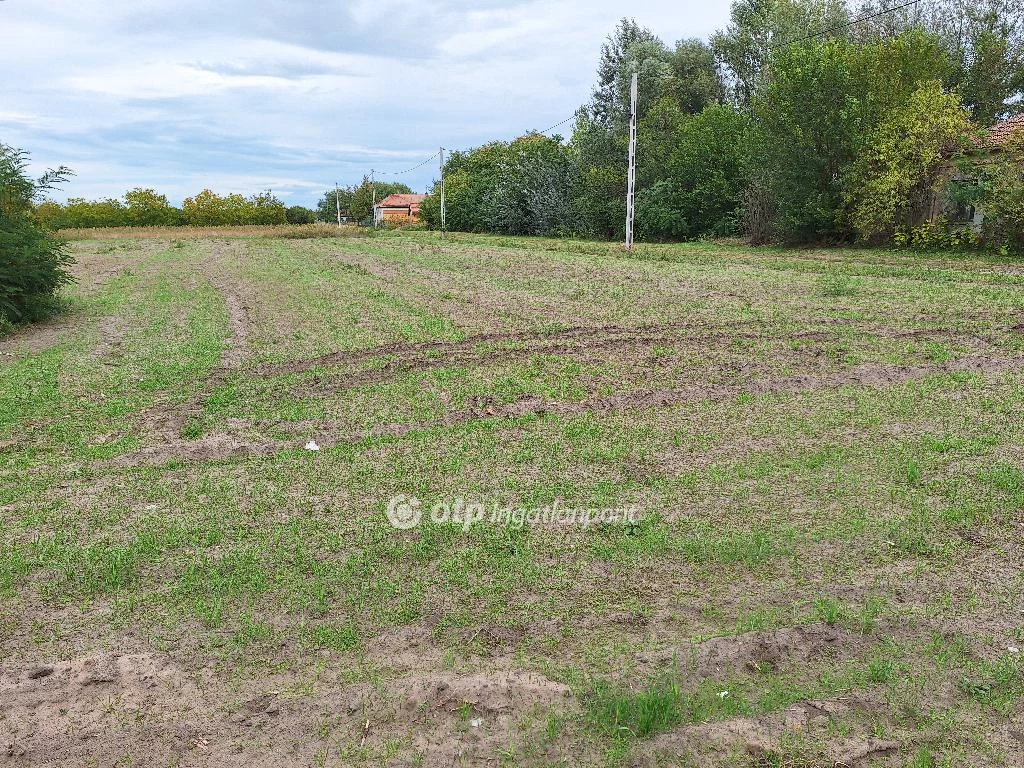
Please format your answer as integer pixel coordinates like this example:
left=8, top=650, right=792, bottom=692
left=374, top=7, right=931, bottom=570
left=745, top=30, right=950, bottom=243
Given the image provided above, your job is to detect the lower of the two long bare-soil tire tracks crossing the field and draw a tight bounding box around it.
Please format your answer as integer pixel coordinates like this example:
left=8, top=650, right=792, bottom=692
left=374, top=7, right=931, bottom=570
left=112, top=355, right=1024, bottom=466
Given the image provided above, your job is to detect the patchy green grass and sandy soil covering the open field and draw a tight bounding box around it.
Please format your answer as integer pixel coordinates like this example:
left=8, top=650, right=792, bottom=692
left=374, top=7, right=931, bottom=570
left=0, top=229, right=1024, bottom=765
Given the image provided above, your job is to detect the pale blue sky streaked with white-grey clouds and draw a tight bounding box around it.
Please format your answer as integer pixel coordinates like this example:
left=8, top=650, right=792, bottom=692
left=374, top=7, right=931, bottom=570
left=0, top=0, right=729, bottom=205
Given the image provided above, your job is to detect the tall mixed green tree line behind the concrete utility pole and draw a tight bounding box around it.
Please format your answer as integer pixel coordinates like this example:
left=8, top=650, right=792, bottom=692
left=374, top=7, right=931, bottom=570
left=422, top=0, right=1024, bottom=249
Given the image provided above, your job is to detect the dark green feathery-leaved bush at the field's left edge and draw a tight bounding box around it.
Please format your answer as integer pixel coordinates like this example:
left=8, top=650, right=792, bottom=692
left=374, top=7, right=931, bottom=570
left=0, top=143, right=73, bottom=327
